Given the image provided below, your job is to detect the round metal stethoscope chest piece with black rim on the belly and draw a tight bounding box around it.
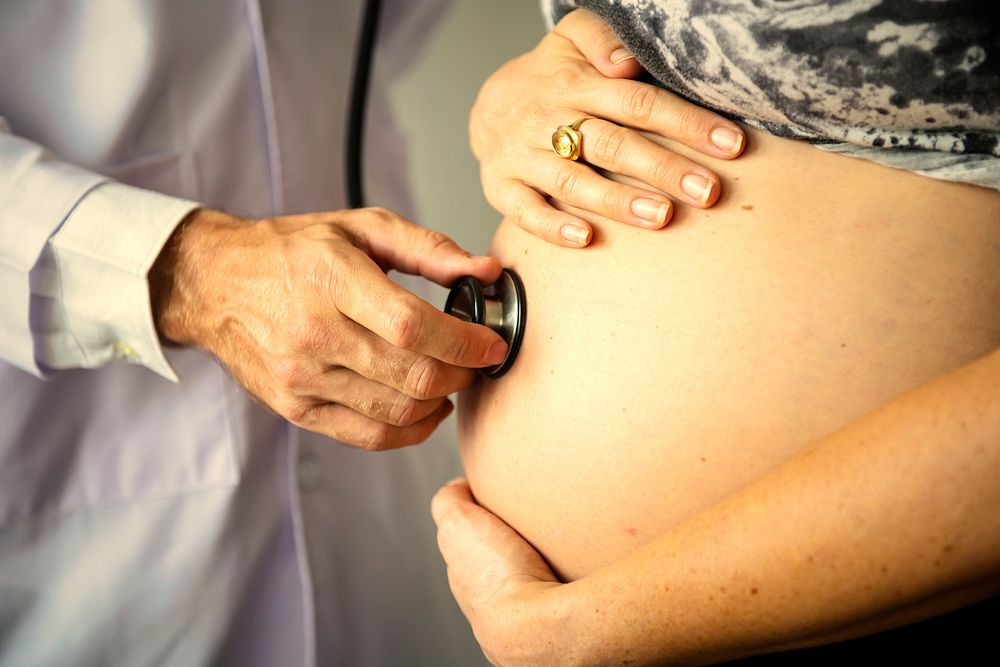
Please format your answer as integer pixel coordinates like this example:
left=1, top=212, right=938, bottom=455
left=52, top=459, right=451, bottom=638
left=444, top=269, right=526, bottom=378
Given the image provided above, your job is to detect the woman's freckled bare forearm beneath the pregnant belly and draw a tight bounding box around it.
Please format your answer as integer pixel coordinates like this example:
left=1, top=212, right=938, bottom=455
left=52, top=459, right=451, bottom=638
left=556, top=351, right=1000, bottom=664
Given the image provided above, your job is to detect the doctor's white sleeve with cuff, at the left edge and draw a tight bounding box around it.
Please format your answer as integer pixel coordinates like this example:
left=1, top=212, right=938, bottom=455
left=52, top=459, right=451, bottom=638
left=0, top=118, right=198, bottom=381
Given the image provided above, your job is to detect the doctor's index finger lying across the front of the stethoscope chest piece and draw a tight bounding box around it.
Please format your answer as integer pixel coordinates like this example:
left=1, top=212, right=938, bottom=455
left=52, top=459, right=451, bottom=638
left=334, top=254, right=507, bottom=371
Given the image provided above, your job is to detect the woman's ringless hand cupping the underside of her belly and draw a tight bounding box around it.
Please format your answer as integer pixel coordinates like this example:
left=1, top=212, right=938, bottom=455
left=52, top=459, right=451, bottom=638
left=431, top=479, right=574, bottom=667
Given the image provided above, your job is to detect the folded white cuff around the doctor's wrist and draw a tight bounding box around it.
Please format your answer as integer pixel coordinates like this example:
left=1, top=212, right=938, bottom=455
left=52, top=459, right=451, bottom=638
left=46, top=182, right=199, bottom=382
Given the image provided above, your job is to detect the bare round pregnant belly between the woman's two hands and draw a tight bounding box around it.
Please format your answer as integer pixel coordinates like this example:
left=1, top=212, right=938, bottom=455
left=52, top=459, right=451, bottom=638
left=459, top=128, right=1000, bottom=579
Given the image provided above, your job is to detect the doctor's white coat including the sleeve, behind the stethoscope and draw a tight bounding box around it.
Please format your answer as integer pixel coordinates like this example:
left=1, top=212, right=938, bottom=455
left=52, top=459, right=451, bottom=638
left=0, top=0, right=484, bottom=667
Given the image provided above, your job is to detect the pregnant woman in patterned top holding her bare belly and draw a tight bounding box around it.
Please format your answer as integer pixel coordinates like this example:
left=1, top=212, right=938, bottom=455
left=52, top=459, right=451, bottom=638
left=434, top=0, right=1000, bottom=665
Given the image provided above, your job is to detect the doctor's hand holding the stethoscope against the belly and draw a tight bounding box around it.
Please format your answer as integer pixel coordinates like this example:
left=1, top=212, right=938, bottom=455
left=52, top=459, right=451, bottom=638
left=150, top=209, right=507, bottom=450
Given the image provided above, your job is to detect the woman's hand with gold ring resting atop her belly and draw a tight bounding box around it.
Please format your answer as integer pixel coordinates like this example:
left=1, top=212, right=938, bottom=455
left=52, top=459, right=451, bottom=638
left=469, top=10, right=746, bottom=247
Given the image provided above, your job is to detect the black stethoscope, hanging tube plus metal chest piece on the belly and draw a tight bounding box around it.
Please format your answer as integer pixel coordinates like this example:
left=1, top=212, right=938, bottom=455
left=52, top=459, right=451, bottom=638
left=345, top=0, right=527, bottom=378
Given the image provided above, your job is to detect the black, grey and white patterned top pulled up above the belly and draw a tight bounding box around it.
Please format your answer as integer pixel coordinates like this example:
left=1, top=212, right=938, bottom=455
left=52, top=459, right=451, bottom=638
left=543, top=0, right=1000, bottom=189
